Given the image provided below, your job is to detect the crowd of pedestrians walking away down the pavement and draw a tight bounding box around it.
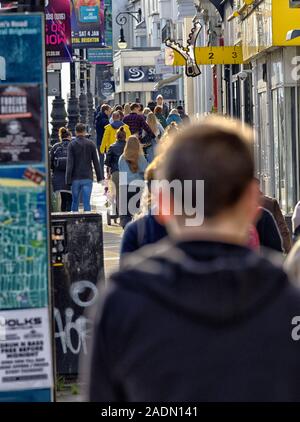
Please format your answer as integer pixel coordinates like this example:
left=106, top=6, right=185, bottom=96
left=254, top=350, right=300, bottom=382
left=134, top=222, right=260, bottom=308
left=50, top=95, right=182, bottom=216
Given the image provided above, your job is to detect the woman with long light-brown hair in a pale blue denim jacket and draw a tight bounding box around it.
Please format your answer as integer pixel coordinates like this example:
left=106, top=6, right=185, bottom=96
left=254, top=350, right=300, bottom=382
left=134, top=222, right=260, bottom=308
left=119, top=136, right=148, bottom=229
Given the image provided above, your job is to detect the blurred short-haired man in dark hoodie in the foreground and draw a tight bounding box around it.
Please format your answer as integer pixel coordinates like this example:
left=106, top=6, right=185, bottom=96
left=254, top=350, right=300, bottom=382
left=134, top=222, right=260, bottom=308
left=88, top=118, right=300, bottom=402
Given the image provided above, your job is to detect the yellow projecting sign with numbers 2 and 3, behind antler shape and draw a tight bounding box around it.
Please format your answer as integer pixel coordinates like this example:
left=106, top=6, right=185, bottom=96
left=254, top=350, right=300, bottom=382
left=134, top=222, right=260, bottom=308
left=166, top=46, right=244, bottom=66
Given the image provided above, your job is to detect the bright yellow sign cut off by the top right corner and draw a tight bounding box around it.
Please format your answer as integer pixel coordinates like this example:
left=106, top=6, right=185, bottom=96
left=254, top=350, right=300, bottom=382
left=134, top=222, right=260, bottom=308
left=272, top=0, right=300, bottom=46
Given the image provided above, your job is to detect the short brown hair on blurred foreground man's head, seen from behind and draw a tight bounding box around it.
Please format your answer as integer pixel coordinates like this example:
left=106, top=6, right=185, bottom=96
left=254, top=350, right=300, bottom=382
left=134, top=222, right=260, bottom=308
left=159, top=117, right=254, bottom=219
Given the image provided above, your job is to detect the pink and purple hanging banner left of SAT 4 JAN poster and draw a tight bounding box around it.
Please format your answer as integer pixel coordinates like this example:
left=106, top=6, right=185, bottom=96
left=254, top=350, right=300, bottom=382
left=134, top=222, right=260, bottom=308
left=45, top=0, right=72, bottom=63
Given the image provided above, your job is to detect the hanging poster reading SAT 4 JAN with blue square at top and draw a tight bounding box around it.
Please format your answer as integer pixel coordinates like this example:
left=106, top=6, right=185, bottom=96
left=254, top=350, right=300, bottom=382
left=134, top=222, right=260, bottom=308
left=71, top=0, right=105, bottom=48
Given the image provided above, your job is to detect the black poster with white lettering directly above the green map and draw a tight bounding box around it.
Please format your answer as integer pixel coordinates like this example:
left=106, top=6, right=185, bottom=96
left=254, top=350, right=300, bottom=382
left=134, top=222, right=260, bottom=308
left=0, top=85, right=42, bottom=164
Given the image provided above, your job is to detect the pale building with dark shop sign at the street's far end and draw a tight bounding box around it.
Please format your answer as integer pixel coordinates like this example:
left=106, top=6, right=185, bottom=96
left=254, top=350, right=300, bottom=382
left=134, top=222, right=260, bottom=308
left=114, top=0, right=183, bottom=105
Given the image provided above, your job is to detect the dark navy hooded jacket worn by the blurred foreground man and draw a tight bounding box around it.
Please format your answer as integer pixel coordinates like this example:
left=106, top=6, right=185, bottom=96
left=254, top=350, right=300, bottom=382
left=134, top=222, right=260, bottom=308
left=88, top=241, right=300, bottom=402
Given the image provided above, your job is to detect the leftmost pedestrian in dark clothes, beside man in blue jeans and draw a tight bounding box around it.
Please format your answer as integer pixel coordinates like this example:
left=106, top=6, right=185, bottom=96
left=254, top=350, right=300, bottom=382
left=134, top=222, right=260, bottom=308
left=50, top=127, right=72, bottom=212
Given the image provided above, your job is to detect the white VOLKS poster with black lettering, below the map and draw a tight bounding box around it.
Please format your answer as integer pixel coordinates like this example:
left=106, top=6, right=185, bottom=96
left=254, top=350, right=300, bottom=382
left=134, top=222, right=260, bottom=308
left=0, top=308, right=52, bottom=391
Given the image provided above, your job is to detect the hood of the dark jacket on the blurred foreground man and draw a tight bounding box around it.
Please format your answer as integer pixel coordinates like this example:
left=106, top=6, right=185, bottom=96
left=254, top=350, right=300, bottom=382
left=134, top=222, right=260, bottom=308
left=112, top=240, right=288, bottom=325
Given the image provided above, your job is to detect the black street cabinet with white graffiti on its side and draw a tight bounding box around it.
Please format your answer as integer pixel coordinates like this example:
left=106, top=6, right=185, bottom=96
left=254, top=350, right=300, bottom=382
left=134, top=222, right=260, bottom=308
left=51, top=213, right=104, bottom=376
